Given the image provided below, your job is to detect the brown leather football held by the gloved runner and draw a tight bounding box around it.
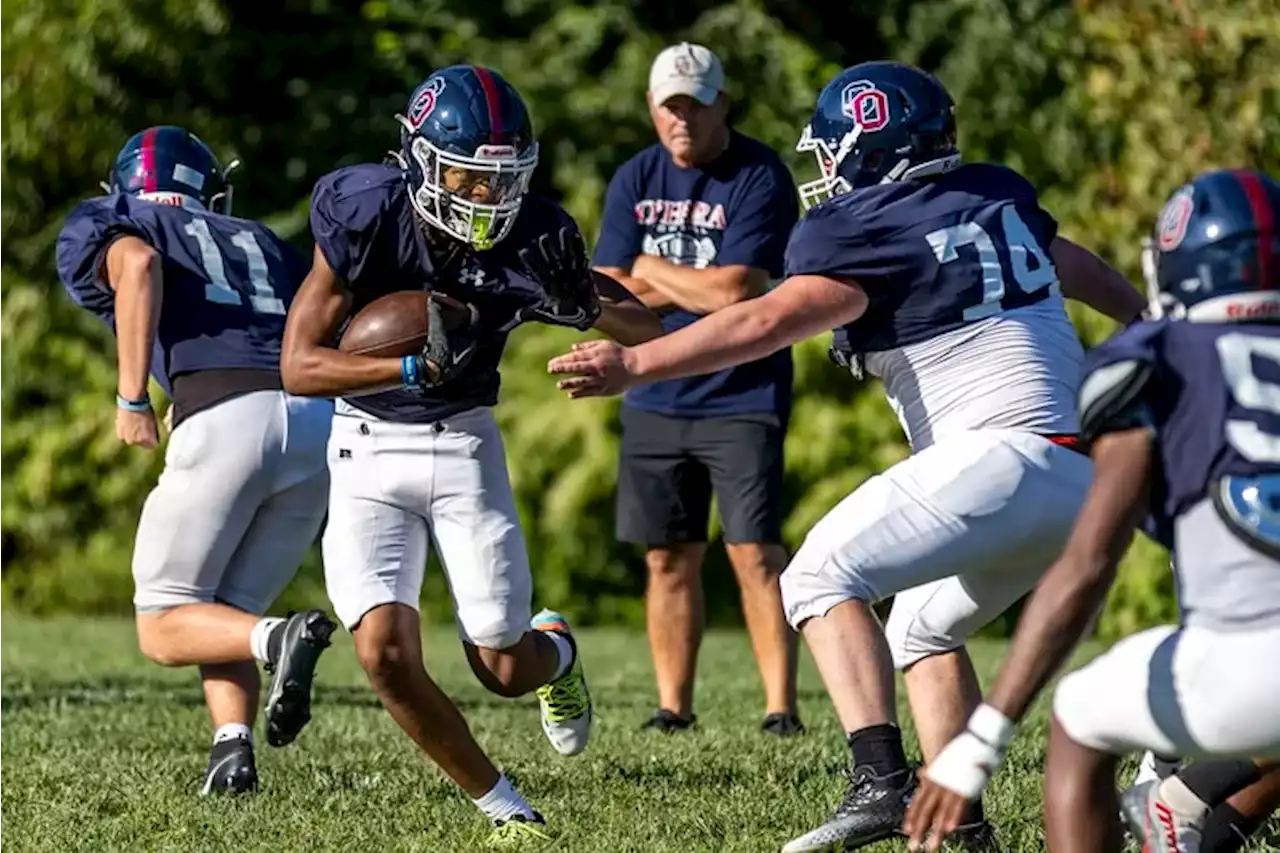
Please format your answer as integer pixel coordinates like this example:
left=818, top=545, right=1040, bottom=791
left=338, top=291, right=471, bottom=357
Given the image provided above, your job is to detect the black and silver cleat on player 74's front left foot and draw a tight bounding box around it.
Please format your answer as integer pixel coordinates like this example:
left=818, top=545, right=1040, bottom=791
left=782, top=767, right=915, bottom=853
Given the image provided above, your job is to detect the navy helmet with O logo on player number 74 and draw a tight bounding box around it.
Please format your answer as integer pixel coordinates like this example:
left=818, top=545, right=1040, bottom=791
left=796, top=61, right=960, bottom=210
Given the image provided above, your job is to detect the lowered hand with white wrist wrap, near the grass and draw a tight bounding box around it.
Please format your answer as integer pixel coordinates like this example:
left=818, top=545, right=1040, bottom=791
left=902, top=730, right=1004, bottom=852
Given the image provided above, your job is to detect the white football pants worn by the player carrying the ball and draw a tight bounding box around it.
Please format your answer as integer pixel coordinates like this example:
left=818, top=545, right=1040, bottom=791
left=323, top=403, right=532, bottom=648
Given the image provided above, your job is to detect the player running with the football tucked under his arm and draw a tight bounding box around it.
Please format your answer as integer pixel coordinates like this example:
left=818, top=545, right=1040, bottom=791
left=283, top=65, right=662, bottom=841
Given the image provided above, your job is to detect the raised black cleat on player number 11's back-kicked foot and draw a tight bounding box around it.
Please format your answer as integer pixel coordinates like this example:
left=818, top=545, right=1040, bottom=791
left=266, top=610, right=338, bottom=747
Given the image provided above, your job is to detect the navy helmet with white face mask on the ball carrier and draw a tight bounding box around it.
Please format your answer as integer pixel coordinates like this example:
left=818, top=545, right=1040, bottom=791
left=396, top=65, right=538, bottom=250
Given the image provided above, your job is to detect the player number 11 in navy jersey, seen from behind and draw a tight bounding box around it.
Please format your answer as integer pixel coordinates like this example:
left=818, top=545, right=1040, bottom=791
left=58, top=126, right=335, bottom=794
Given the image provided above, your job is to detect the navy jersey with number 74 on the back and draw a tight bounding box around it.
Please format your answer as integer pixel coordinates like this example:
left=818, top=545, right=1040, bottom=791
left=786, top=164, right=1060, bottom=353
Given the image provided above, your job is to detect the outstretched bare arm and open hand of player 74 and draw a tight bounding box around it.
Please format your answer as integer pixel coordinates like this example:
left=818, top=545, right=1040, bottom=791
left=547, top=275, right=867, bottom=398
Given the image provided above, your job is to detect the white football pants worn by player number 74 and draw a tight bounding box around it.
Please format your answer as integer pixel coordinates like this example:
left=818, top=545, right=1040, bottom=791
left=782, top=429, right=1093, bottom=669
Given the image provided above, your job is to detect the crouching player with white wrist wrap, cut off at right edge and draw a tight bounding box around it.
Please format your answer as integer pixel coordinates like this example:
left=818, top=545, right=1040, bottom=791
left=908, top=170, right=1280, bottom=853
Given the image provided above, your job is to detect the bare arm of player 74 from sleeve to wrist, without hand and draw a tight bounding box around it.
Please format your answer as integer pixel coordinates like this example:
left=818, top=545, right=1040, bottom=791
left=632, top=275, right=867, bottom=382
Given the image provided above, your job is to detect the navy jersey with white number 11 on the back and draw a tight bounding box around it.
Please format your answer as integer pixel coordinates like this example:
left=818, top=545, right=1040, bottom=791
left=56, top=195, right=306, bottom=394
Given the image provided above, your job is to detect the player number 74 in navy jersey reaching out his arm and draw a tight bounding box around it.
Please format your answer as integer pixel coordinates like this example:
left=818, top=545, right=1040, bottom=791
left=550, top=61, right=1143, bottom=852
